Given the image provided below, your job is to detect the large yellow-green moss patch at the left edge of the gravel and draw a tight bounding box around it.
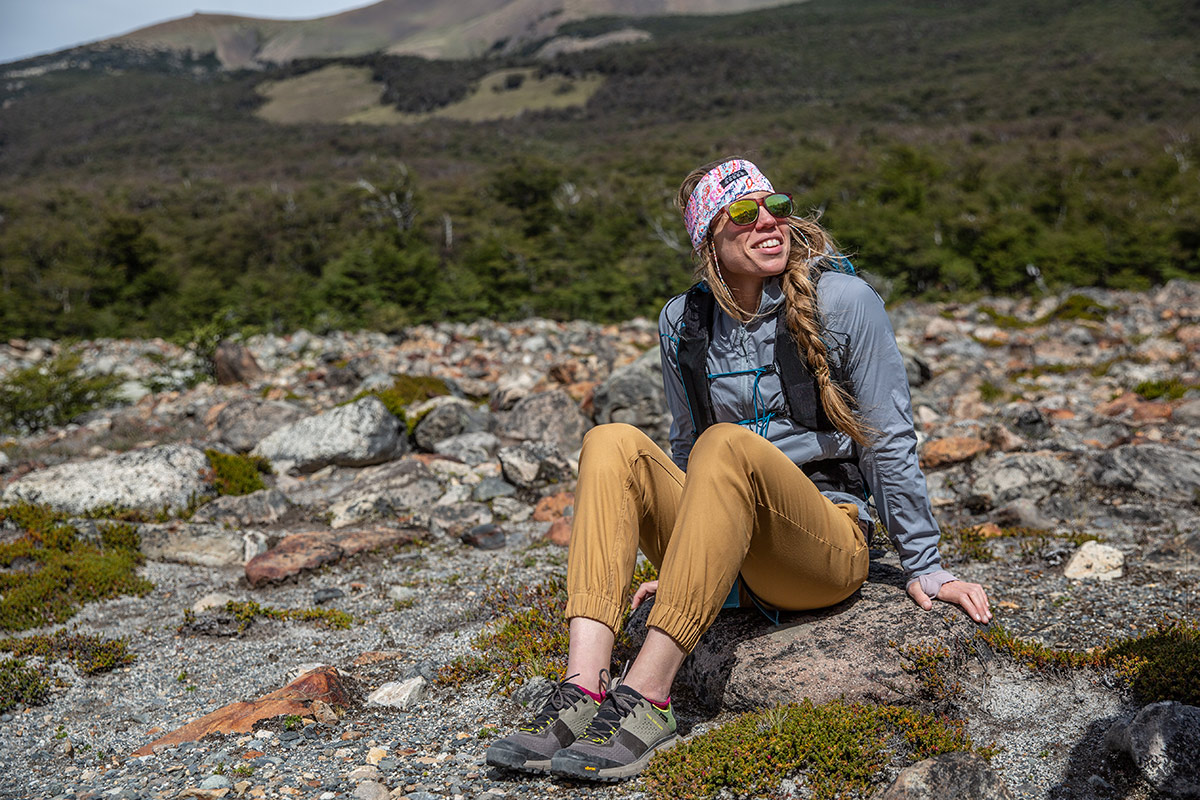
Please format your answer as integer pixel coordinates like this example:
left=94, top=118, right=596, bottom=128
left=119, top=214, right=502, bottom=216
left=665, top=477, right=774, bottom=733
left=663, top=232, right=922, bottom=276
left=0, top=503, right=154, bottom=631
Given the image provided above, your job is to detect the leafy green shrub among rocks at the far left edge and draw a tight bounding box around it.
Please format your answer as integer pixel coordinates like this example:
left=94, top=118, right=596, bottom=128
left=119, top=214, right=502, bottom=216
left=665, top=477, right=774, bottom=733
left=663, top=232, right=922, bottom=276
left=0, top=353, right=120, bottom=433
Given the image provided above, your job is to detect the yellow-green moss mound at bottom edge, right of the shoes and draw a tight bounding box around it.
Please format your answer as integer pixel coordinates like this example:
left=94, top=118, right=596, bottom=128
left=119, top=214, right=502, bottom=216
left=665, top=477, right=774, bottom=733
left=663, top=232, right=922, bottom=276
left=643, top=699, right=994, bottom=800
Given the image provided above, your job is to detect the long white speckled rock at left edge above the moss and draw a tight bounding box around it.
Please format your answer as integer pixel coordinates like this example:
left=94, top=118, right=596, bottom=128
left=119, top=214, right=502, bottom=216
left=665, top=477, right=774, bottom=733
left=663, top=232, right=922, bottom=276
left=4, top=445, right=212, bottom=515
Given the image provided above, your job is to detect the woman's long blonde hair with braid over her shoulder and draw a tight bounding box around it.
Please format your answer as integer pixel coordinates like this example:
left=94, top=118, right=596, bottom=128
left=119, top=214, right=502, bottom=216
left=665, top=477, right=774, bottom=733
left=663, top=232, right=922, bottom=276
left=676, top=158, right=872, bottom=446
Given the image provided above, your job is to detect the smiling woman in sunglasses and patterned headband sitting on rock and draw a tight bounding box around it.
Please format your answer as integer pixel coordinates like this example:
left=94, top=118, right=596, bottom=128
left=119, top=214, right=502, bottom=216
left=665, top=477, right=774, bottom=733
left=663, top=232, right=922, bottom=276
left=487, top=158, right=991, bottom=781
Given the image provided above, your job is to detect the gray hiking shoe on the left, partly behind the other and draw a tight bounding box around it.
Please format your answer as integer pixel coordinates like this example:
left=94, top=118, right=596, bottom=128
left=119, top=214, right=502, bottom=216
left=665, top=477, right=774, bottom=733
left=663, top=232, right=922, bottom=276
left=487, top=675, right=600, bottom=772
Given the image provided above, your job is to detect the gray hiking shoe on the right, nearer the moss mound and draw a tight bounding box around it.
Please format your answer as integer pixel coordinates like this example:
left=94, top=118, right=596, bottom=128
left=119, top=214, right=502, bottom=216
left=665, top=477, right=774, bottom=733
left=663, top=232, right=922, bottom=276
left=550, top=686, right=679, bottom=782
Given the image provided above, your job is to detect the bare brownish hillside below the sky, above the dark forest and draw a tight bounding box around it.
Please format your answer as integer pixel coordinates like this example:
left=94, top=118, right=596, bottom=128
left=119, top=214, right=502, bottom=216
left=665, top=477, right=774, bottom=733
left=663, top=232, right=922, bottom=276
left=103, top=0, right=796, bottom=68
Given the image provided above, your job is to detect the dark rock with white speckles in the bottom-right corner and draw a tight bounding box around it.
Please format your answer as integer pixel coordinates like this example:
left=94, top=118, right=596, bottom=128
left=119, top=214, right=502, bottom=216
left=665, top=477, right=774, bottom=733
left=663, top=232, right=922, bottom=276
left=1105, top=700, right=1200, bottom=799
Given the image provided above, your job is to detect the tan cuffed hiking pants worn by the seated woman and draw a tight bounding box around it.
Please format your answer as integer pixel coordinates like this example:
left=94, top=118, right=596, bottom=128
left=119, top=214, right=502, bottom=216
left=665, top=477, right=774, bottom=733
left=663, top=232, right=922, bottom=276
left=566, top=423, right=868, bottom=651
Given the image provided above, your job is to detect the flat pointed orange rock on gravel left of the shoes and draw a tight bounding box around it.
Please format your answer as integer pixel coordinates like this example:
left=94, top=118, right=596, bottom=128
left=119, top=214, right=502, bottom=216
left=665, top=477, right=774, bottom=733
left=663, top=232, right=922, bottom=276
left=133, top=667, right=354, bottom=756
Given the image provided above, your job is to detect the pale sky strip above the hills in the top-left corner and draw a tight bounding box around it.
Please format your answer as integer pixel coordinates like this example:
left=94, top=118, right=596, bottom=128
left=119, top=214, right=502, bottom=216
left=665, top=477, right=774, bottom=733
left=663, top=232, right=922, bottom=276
left=0, top=0, right=373, bottom=64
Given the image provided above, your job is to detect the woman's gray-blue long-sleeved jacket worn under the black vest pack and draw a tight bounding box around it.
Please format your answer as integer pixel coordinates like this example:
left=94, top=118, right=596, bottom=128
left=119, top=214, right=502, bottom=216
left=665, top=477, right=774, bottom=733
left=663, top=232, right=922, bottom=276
left=659, top=271, right=954, bottom=587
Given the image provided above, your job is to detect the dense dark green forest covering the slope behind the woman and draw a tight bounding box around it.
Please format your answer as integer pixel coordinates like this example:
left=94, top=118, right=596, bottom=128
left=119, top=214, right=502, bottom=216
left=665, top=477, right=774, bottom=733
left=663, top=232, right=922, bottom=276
left=0, top=0, right=1200, bottom=337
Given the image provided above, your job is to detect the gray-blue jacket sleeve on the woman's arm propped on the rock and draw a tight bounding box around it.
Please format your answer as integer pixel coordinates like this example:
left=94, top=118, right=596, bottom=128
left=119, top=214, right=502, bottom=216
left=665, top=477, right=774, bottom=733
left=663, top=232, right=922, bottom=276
left=821, top=278, right=954, bottom=585
